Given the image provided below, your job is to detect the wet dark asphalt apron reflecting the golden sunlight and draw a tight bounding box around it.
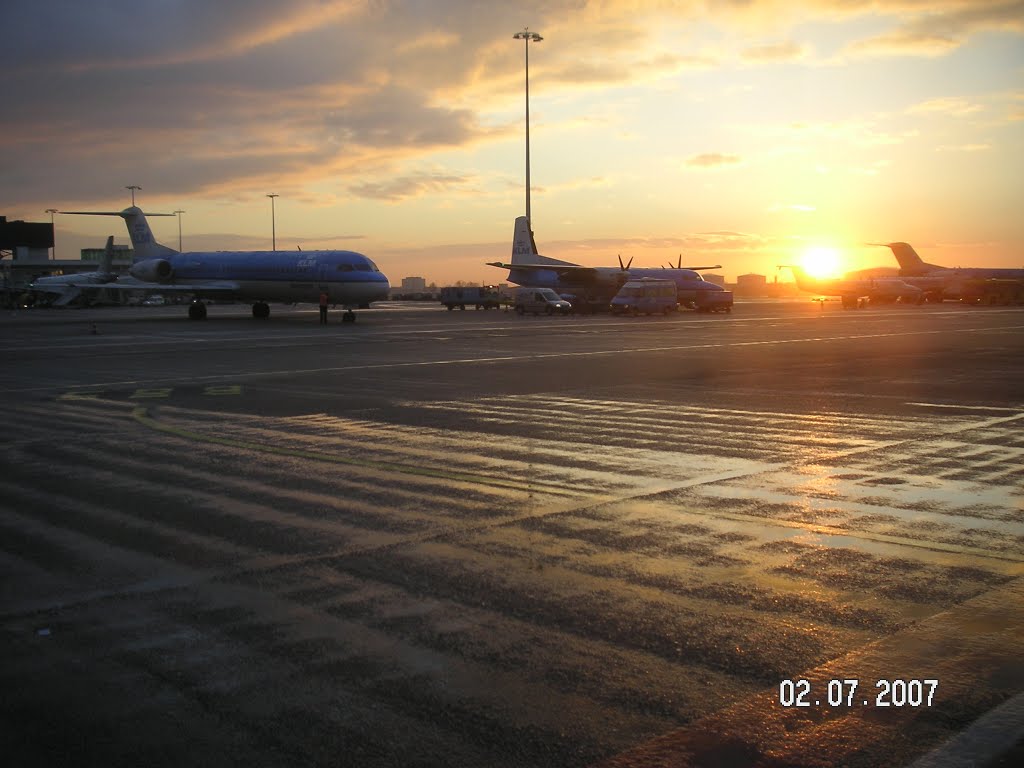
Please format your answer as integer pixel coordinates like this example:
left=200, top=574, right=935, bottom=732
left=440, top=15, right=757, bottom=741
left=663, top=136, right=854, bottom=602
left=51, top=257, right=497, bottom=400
left=0, top=301, right=1024, bottom=766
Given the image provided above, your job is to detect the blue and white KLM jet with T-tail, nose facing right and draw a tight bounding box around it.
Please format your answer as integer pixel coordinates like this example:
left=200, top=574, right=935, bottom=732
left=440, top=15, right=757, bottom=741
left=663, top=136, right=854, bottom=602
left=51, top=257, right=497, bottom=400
left=60, top=206, right=390, bottom=323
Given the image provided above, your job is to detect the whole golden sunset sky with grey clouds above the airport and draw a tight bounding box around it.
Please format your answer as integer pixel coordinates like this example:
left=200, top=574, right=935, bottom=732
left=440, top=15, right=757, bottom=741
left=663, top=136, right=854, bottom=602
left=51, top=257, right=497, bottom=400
left=0, top=0, right=1024, bottom=285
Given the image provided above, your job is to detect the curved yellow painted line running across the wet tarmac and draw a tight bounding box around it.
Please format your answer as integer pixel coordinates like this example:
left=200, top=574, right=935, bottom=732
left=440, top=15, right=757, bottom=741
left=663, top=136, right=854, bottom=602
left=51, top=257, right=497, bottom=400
left=132, top=406, right=582, bottom=498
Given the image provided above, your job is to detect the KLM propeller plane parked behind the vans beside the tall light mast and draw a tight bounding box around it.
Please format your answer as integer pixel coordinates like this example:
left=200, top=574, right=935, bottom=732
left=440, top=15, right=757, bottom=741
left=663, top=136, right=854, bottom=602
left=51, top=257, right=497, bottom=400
left=487, top=216, right=724, bottom=308
